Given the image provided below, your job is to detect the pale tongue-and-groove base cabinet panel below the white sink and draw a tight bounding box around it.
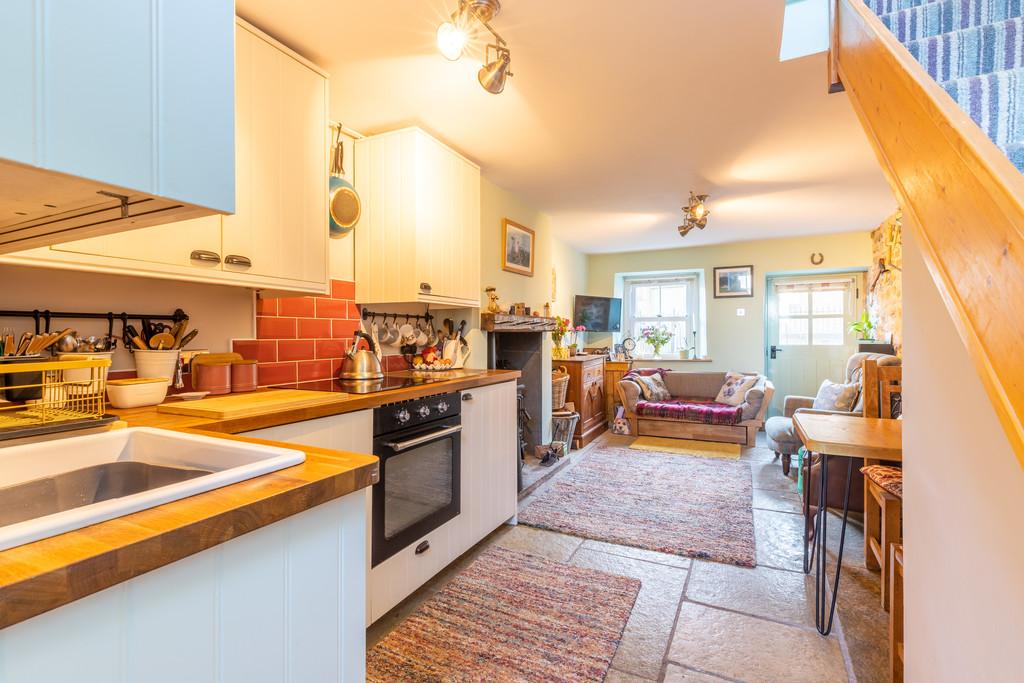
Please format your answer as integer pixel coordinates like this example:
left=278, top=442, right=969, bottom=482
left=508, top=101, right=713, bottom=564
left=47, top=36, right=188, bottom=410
left=0, top=492, right=367, bottom=683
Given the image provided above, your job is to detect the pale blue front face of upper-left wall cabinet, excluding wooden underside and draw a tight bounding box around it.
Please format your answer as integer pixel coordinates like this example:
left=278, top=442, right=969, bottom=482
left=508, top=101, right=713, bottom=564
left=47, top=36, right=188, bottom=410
left=15, top=0, right=234, bottom=212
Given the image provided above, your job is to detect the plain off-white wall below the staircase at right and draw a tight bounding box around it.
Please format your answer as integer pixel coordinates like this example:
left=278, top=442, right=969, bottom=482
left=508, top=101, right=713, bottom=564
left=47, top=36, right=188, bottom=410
left=903, top=228, right=1024, bottom=682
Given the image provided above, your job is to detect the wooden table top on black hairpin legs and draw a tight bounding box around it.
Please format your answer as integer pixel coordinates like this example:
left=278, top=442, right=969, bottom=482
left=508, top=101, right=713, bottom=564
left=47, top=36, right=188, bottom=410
left=793, top=413, right=903, bottom=462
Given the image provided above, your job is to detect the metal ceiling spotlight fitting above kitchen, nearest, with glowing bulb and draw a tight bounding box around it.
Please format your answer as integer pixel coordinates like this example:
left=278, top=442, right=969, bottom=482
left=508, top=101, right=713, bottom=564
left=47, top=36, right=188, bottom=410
left=437, top=0, right=512, bottom=95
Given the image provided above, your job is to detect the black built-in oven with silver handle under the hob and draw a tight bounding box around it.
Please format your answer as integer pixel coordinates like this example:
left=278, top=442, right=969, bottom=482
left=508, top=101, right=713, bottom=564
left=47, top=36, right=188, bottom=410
left=371, top=392, right=462, bottom=566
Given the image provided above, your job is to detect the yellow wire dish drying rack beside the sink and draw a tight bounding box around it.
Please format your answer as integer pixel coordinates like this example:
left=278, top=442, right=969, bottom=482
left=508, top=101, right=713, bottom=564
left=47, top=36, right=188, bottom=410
left=0, top=358, right=117, bottom=440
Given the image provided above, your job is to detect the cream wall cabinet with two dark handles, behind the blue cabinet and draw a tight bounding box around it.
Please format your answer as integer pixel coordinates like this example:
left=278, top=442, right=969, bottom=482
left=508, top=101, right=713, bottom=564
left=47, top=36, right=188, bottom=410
left=3, top=19, right=330, bottom=293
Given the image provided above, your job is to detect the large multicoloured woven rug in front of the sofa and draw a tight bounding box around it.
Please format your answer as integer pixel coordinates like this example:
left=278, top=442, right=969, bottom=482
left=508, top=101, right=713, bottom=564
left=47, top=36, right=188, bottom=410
left=519, top=449, right=757, bottom=567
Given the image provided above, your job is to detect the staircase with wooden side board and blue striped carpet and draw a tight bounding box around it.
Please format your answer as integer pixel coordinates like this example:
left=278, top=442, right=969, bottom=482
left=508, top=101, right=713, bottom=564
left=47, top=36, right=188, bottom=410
left=829, top=0, right=1024, bottom=466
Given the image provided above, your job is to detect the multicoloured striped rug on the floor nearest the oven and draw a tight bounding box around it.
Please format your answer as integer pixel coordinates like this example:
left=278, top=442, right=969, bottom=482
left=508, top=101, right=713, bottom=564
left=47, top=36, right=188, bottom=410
left=367, top=547, right=640, bottom=683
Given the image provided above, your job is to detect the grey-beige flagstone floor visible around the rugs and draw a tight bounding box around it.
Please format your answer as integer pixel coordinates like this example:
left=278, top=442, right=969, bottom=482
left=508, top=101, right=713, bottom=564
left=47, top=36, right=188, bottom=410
left=367, top=434, right=889, bottom=683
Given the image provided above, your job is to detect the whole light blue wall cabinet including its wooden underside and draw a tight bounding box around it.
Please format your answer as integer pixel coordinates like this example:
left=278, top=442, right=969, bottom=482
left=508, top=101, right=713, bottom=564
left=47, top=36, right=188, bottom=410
left=0, top=0, right=234, bottom=252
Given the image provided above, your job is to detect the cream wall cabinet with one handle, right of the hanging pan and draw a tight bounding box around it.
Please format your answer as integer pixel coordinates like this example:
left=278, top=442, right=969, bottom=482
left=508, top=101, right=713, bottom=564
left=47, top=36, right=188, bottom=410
left=355, top=128, right=480, bottom=307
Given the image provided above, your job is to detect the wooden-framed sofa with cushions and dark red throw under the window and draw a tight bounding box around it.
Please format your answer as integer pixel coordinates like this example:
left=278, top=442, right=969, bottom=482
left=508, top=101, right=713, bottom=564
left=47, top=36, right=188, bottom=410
left=616, top=369, right=775, bottom=446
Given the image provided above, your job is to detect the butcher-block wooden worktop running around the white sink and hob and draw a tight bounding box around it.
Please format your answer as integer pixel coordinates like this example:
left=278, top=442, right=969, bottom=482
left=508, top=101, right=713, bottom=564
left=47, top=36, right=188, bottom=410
left=0, top=371, right=520, bottom=628
